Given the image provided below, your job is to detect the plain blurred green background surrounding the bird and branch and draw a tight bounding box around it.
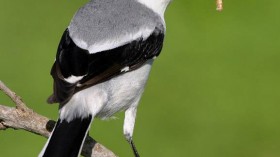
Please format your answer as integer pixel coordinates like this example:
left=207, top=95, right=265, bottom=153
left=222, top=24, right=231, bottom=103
left=0, top=0, right=280, bottom=157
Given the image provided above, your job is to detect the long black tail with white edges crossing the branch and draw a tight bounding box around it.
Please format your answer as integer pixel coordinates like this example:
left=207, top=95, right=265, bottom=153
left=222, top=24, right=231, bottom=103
left=39, top=116, right=92, bottom=157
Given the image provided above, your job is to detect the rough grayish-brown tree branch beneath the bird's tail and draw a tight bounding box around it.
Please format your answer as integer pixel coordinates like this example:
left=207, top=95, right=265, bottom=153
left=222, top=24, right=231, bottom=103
left=0, top=81, right=116, bottom=157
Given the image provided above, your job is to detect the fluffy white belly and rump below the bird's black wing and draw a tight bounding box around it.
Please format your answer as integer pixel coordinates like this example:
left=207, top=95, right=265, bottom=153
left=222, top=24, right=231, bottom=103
left=60, top=60, right=153, bottom=121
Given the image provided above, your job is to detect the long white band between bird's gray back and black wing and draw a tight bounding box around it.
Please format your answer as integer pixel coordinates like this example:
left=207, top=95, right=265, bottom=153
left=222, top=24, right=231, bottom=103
left=70, top=28, right=154, bottom=54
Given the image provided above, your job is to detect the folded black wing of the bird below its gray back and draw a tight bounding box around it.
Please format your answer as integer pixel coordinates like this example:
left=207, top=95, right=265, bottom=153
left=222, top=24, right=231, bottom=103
left=48, top=28, right=164, bottom=104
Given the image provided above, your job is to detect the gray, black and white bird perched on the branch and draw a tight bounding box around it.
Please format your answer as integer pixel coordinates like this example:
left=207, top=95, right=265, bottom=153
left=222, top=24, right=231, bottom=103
left=39, top=0, right=170, bottom=157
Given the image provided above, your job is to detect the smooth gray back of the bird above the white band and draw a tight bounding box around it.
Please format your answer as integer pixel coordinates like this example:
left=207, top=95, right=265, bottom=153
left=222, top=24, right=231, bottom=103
left=68, top=0, right=165, bottom=49
